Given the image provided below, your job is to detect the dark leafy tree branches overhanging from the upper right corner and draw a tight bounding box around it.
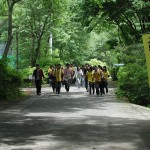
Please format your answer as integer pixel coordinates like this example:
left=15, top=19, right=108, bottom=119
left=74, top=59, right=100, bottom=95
left=78, top=0, right=150, bottom=44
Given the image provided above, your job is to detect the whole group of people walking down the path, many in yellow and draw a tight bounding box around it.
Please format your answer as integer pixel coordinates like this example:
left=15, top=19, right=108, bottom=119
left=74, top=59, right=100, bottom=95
left=33, top=63, right=109, bottom=95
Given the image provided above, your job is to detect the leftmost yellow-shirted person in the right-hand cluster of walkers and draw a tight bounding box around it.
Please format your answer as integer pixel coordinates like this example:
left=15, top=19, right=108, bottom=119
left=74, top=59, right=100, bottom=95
left=86, top=66, right=95, bottom=95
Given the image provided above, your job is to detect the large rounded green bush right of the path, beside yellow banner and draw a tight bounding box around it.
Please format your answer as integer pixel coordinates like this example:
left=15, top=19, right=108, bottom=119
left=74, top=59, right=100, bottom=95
left=117, top=46, right=150, bottom=106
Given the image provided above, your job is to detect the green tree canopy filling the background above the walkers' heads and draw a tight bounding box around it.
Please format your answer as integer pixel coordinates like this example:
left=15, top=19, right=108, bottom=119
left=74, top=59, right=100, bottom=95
left=0, top=0, right=150, bottom=69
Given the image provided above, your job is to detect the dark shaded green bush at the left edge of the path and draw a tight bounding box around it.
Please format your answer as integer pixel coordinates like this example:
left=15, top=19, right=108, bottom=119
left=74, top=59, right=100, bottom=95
left=0, top=61, right=22, bottom=100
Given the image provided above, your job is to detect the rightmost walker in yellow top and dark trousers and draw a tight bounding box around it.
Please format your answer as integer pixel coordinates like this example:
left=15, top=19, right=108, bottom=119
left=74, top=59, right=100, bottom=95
left=103, top=66, right=110, bottom=93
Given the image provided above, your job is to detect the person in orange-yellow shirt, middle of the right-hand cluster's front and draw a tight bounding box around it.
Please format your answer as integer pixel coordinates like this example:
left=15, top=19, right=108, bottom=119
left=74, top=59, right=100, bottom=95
left=93, top=67, right=103, bottom=95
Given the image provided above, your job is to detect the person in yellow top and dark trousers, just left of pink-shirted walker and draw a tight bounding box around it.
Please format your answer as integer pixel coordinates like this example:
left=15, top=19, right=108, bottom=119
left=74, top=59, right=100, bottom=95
left=54, top=64, right=62, bottom=94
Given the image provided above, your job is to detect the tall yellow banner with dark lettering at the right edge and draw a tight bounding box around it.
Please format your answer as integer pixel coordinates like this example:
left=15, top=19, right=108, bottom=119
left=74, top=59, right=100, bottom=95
left=143, top=34, right=150, bottom=86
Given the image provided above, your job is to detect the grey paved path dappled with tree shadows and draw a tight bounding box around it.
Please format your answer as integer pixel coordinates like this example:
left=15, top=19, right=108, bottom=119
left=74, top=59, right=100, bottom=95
left=0, top=87, right=150, bottom=150
